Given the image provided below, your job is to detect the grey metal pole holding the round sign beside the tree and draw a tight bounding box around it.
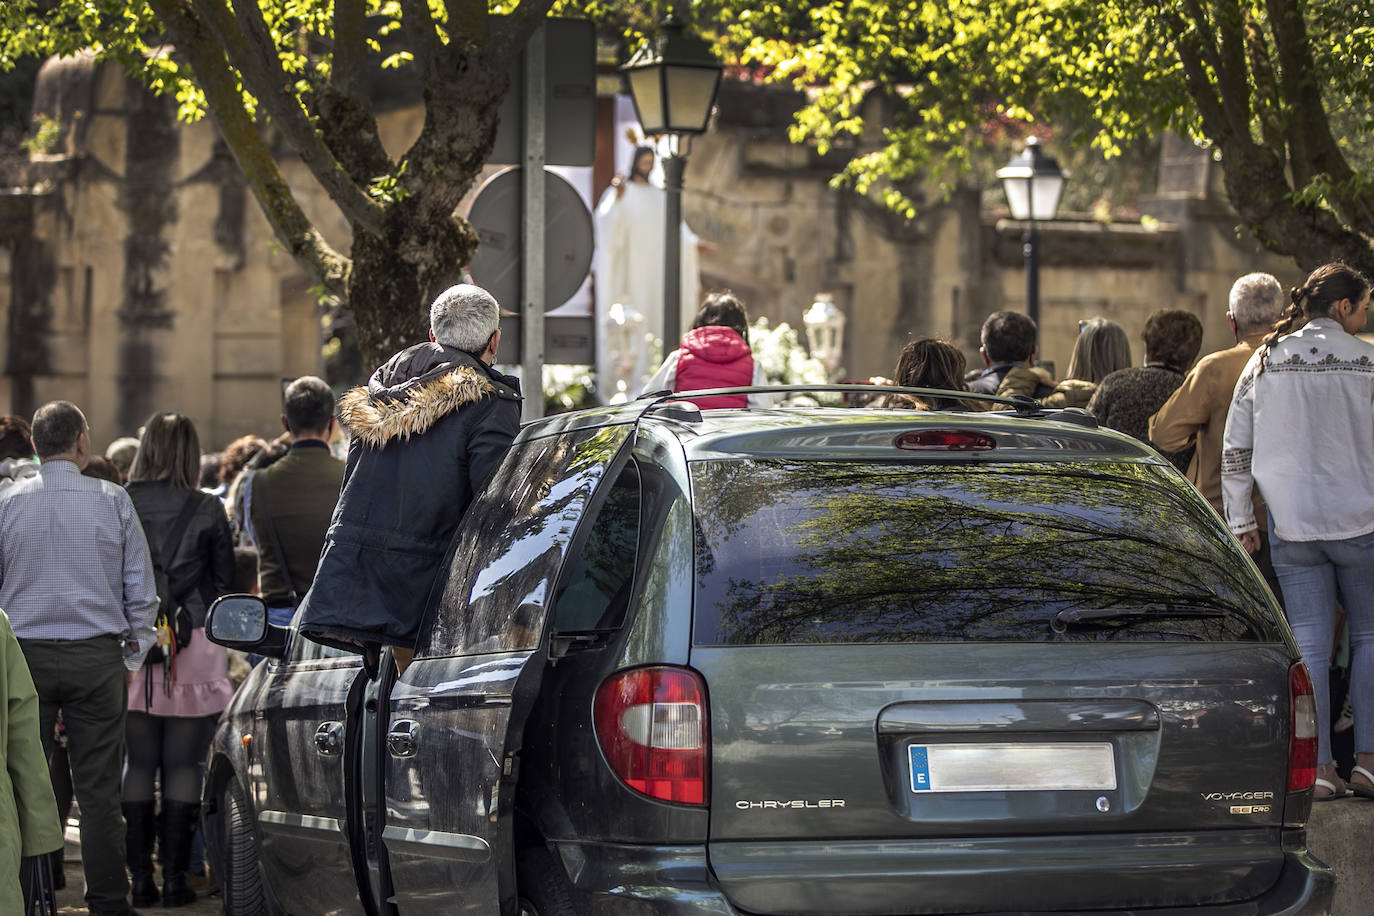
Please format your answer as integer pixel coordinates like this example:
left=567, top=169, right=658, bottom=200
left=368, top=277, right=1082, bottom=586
left=519, top=26, right=548, bottom=420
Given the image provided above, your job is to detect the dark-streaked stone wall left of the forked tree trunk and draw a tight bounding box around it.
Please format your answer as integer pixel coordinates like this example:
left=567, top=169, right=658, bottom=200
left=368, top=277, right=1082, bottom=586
left=0, top=56, right=319, bottom=448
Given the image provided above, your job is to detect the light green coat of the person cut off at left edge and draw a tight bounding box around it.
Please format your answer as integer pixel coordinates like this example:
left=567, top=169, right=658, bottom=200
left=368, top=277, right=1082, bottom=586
left=0, top=610, right=62, bottom=913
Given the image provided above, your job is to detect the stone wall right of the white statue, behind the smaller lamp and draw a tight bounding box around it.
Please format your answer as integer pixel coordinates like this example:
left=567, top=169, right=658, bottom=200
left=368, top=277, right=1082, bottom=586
left=683, top=84, right=1301, bottom=376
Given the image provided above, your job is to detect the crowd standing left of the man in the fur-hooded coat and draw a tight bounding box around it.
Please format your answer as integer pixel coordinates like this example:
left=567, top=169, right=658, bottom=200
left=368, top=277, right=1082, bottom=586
left=0, top=376, right=354, bottom=913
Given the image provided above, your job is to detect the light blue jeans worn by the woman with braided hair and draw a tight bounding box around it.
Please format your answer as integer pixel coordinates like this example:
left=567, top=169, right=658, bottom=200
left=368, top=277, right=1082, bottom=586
left=1270, top=533, right=1374, bottom=764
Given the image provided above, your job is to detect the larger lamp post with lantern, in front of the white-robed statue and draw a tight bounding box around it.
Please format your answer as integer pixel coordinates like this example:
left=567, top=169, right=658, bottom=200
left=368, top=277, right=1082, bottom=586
left=621, top=14, right=724, bottom=353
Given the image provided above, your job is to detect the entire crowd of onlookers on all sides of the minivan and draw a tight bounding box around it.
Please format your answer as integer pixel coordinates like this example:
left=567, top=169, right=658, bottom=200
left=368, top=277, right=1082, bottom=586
left=0, top=264, right=1374, bottom=915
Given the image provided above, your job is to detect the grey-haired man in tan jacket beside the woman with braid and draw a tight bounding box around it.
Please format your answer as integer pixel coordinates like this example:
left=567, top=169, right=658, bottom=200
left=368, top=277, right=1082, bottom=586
left=1150, top=273, right=1287, bottom=595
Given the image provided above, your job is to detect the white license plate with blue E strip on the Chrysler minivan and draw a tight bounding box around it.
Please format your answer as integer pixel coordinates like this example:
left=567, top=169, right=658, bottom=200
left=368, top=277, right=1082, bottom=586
left=907, top=742, right=1116, bottom=792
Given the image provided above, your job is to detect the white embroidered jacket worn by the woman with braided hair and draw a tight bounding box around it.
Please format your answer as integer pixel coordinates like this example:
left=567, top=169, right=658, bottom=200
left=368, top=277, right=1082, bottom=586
left=1221, top=319, right=1374, bottom=541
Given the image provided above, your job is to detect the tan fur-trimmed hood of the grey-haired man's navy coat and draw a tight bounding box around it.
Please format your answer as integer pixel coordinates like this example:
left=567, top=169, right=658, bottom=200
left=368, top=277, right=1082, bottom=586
left=338, top=343, right=519, bottom=448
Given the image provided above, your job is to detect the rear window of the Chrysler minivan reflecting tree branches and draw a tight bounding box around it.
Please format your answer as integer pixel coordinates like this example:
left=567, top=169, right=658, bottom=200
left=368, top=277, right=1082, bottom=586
left=691, top=459, right=1283, bottom=645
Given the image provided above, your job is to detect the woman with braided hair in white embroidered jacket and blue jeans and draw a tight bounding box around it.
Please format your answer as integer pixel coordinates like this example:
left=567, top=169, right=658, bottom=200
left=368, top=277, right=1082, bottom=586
left=1221, top=264, right=1374, bottom=801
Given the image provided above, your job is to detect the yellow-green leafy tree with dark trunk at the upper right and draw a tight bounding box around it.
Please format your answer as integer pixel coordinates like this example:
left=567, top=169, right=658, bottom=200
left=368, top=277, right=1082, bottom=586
left=721, top=0, right=1374, bottom=276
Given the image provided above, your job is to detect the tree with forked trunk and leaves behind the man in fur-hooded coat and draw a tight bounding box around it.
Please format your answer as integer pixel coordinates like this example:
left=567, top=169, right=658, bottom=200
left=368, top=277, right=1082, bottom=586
left=0, top=0, right=637, bottom=364
